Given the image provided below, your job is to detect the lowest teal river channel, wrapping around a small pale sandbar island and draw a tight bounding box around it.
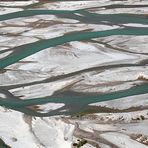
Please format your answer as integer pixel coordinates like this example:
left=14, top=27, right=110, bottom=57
left=0, top=84, right=148, bottom=116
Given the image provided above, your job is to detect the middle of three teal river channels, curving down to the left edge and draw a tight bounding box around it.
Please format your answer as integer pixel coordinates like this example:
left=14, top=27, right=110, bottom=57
left=0, top=28, right=148, bottom=69
